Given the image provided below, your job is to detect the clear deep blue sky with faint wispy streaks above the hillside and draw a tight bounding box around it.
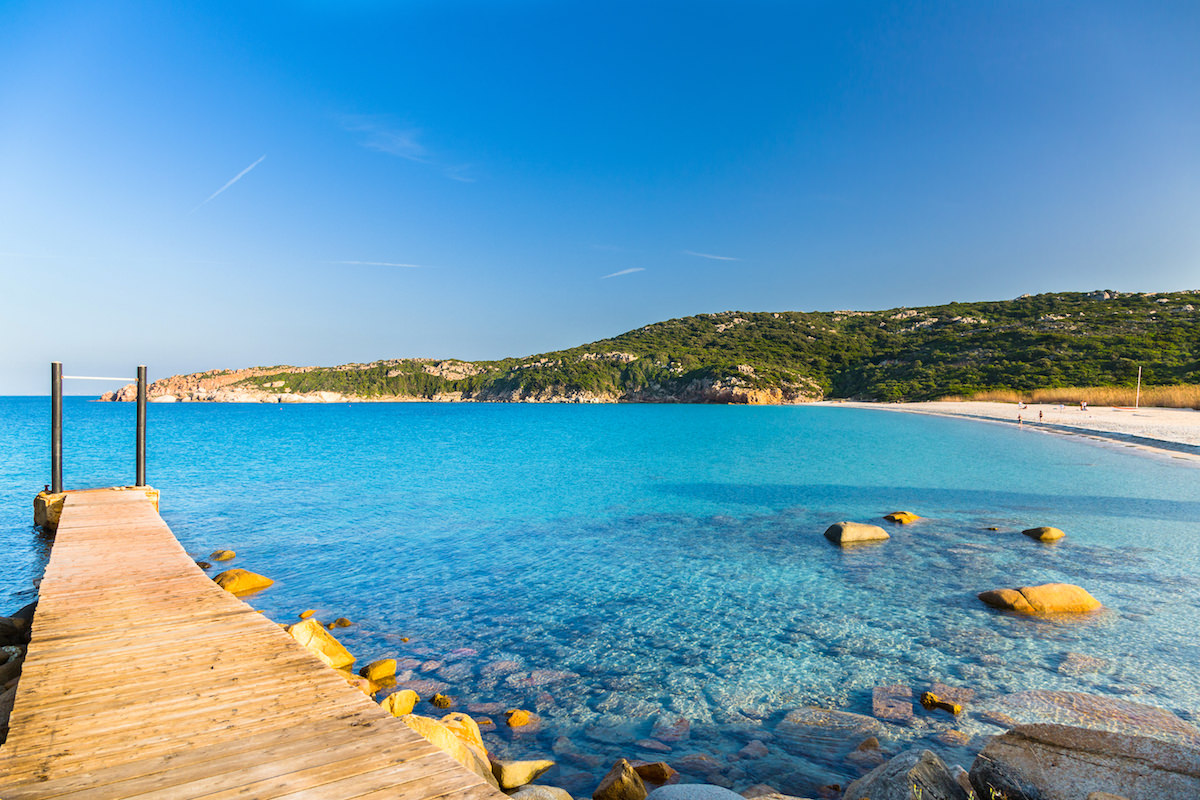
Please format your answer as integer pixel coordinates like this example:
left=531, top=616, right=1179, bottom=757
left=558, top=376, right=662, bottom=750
left=0, top=0, right=1200, bottom=393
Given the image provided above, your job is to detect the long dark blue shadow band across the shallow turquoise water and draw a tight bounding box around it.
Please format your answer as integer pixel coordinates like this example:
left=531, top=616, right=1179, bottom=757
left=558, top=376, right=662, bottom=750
left=656, top=483, right=1200, bottom=522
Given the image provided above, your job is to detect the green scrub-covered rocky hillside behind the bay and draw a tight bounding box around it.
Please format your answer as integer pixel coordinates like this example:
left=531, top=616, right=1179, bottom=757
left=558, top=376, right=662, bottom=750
left=226, top=291, right=1200, bottom=402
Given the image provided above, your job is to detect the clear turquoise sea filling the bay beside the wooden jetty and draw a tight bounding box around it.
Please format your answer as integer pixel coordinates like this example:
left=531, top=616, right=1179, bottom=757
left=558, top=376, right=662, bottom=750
left=0, top=398, right=1200, bottom=794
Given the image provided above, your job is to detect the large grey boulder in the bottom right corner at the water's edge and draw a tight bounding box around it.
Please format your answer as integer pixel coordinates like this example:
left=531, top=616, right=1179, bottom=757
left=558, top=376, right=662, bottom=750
left=969, top=724, right=1200, bottom=800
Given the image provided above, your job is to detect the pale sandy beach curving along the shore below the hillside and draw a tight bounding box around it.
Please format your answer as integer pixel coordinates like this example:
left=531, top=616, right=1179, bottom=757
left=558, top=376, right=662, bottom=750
left=822, top=401, right=1200, bottom=462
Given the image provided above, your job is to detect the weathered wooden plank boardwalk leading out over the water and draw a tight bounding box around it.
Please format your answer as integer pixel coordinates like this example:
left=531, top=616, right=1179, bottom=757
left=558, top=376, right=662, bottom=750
left=0, top=489, right=504, bottom=800
